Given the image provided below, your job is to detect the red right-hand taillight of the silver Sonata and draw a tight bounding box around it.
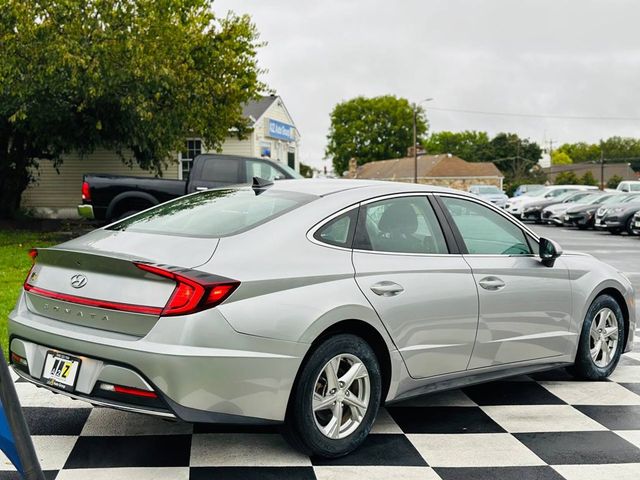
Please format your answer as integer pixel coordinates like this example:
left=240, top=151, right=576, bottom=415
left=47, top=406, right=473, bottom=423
left=134, top=262, right=240, bottom=316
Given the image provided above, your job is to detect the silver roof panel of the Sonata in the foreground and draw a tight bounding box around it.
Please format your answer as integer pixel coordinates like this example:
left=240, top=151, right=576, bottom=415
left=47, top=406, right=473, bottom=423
left=270, top=178, right=468, bottom=197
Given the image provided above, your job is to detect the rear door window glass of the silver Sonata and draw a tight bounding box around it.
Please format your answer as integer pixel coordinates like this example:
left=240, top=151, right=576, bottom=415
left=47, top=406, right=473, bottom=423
left=354, top=197, right=448, bottom=254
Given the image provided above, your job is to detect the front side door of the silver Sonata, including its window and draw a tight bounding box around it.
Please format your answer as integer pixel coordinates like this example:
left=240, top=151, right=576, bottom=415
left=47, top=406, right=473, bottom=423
left=438, top=194, right=572, bottom=369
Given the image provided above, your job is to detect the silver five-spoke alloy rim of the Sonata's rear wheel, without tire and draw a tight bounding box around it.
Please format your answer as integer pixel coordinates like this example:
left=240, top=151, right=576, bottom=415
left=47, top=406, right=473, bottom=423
left=312, top=354, right=371, bottom=439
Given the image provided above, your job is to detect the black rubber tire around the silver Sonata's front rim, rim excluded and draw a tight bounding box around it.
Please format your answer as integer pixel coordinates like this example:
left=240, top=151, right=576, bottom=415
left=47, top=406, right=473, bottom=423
left=569, top=295, right=626, bottom=380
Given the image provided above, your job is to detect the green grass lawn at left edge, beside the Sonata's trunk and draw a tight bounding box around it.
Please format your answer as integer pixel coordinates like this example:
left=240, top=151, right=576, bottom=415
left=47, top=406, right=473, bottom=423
left=0, top=230, right=61, bottom=356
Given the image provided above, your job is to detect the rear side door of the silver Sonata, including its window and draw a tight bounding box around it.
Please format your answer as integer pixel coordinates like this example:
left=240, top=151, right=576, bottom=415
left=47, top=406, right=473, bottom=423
left=353, top=195, right=478, bottom=378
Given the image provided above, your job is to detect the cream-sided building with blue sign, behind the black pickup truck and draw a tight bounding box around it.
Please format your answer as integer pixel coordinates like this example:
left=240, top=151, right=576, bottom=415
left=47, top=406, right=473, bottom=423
left=21, top=95, right=300, bottom=218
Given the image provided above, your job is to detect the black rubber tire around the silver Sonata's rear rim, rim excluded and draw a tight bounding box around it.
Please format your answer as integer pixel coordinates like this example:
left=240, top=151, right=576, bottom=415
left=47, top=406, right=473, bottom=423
left=283, top=334, right=382, bottom=458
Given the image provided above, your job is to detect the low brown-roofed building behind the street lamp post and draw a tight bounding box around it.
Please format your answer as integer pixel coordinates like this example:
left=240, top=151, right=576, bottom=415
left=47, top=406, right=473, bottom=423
left=347, top=154, right=504, bottom=191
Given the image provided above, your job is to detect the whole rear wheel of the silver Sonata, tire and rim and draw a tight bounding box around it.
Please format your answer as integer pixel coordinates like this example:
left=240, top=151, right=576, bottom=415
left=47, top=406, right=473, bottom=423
left=284, top=334, right=382, bottom=458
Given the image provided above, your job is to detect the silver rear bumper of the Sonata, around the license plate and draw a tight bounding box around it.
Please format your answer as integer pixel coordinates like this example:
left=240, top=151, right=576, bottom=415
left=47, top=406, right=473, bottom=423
left=9, top=295, right=309, bottom=424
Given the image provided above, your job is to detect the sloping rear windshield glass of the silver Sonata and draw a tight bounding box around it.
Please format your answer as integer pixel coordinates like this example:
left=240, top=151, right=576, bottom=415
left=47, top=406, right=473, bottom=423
left=107, top=188, right=317, bottom=238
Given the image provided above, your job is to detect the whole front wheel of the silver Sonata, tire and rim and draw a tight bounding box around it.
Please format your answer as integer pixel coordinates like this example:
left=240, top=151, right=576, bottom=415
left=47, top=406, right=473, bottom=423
left=571, top=295, right=625, bottom=380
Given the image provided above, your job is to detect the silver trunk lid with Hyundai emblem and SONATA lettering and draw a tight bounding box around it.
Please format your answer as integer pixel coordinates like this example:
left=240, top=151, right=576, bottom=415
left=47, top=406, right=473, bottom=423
left=25, top=230, right=218, bottom=337
